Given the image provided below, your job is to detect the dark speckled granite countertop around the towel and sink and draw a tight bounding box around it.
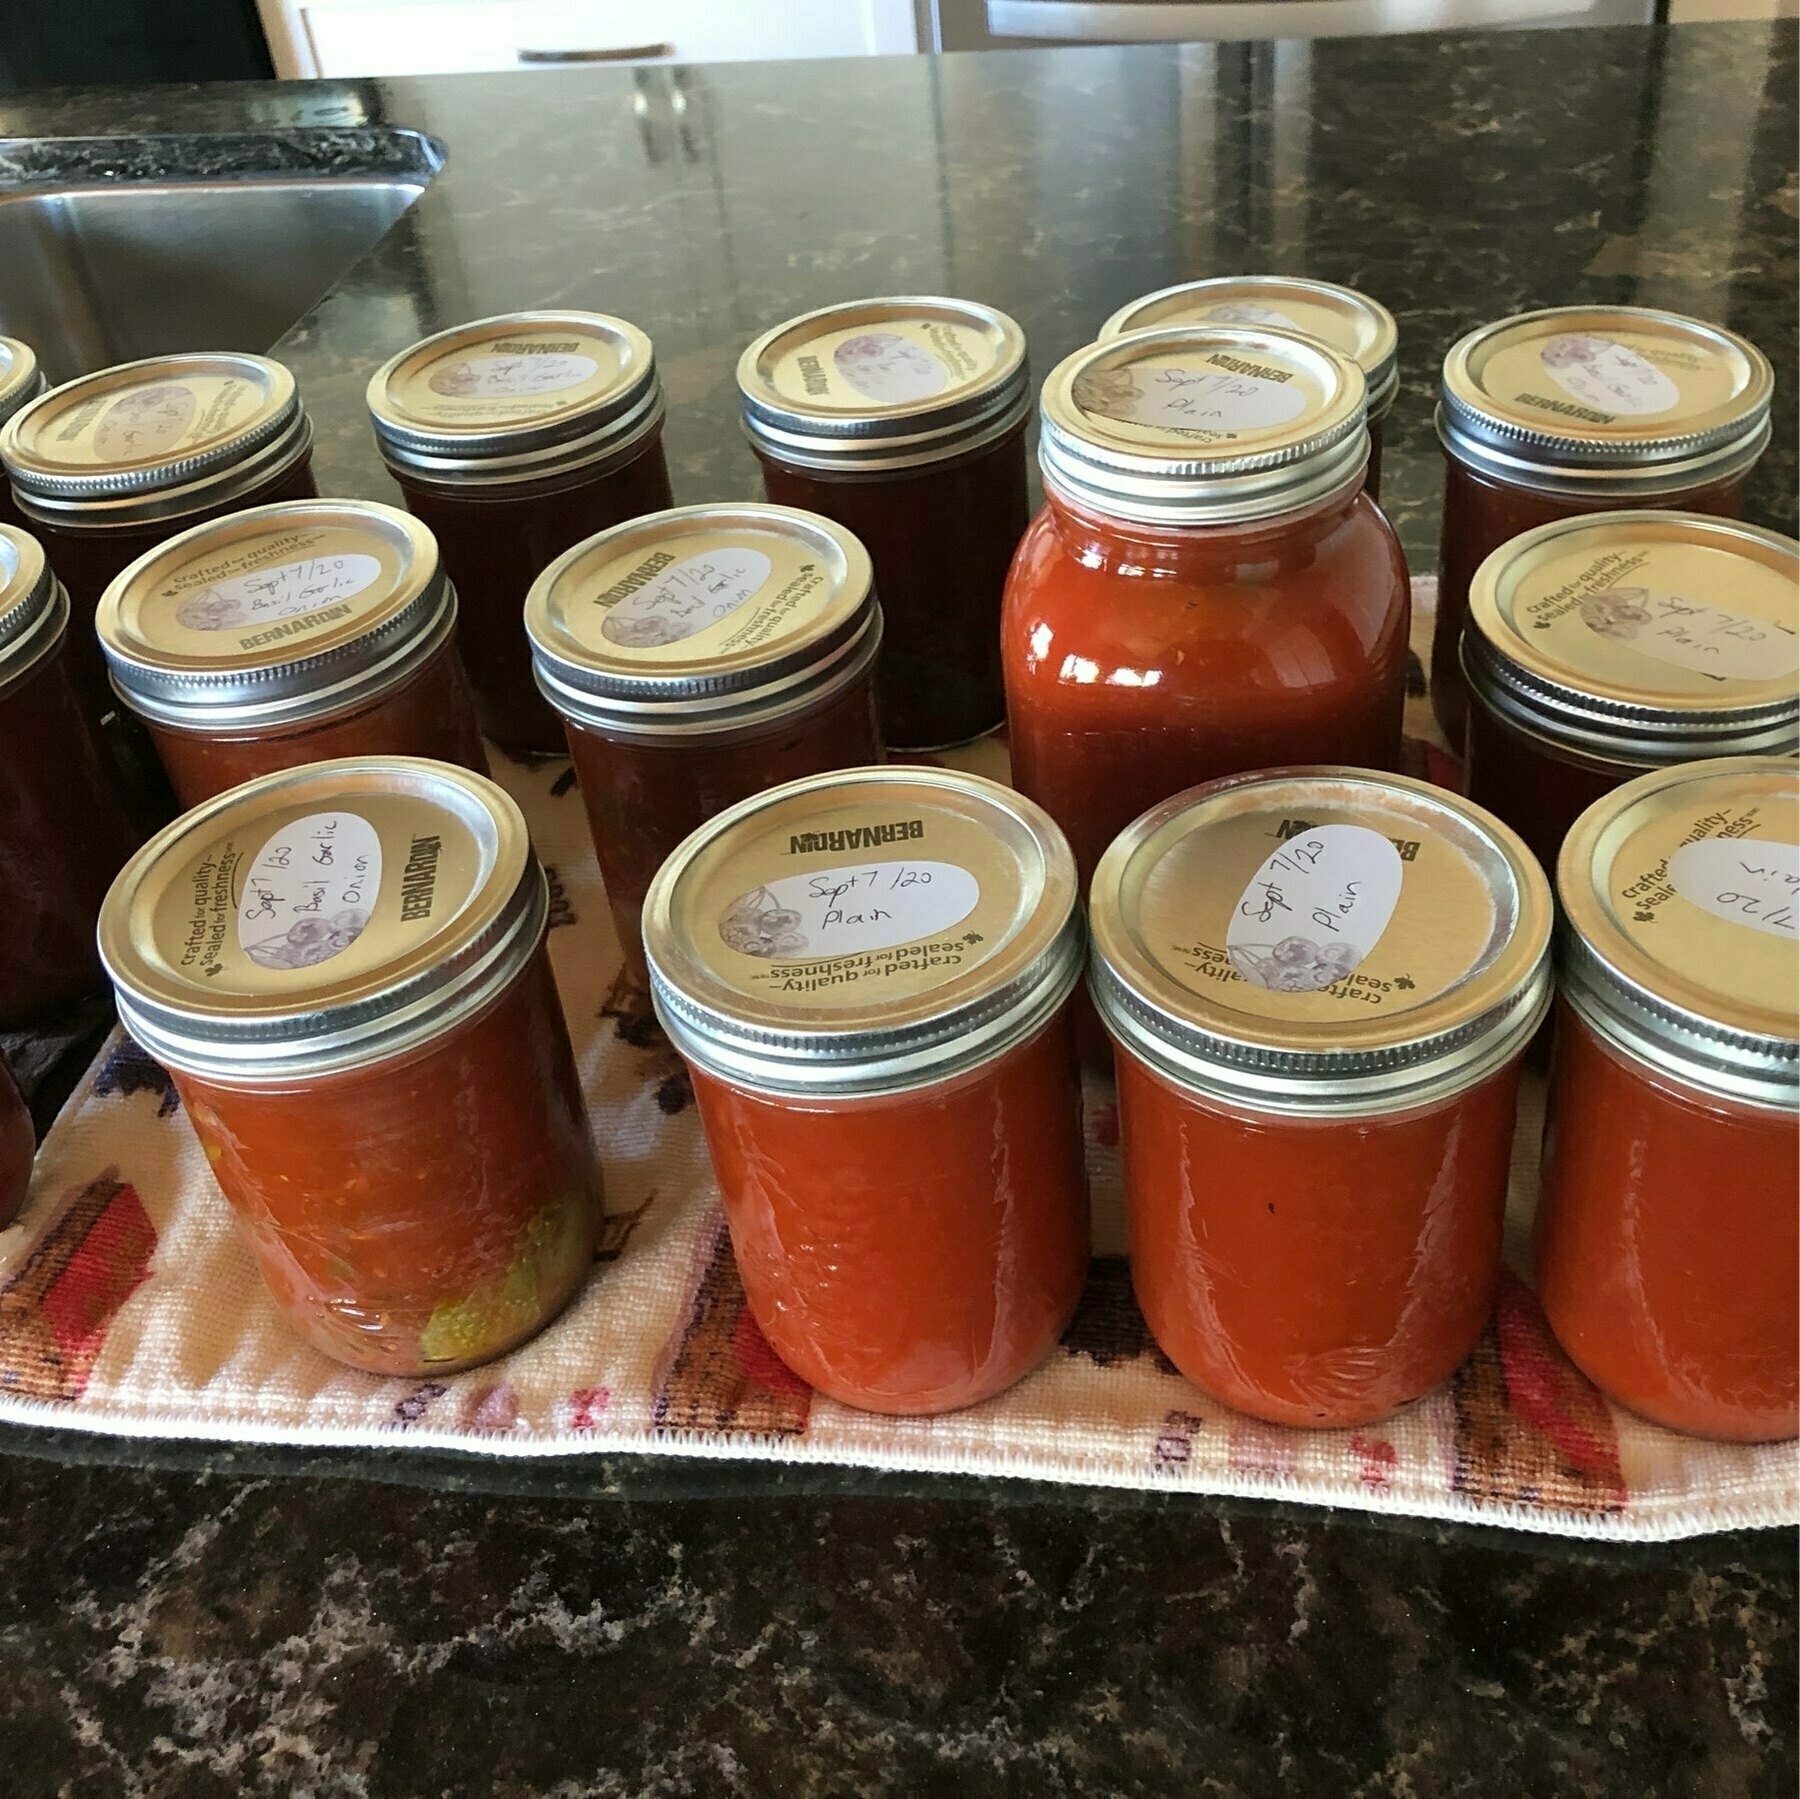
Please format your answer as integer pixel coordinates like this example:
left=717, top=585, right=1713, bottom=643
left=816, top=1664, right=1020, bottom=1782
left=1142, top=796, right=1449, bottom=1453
left=0, top=25, right=1800, bottom=1799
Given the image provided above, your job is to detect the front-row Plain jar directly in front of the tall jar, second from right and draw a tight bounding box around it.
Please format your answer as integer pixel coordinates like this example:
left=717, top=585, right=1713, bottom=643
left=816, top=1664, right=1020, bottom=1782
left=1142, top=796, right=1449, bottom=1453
left=1089, top=769, right=1552, bottom=1428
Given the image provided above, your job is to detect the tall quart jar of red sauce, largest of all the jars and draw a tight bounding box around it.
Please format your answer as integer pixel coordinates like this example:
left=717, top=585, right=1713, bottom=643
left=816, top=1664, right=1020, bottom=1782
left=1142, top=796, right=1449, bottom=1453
left=1003, top=326, right=1409, bottom=881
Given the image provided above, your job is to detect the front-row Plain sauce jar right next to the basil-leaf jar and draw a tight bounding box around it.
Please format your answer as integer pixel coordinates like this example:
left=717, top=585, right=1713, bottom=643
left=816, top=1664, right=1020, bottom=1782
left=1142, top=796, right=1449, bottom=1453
left=644, top=767, right=1087, bottom=1414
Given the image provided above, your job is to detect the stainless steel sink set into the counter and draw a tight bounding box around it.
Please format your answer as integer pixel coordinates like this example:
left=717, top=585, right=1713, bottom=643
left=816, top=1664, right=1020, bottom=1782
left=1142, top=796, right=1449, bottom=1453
left=0, top=126, right=443, bottom=382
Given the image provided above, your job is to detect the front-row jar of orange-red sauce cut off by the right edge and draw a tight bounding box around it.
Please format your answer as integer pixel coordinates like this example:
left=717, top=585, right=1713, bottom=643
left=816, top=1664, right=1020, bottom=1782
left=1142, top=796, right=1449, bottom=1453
left=1535, top=756, right=1800, bottom=1442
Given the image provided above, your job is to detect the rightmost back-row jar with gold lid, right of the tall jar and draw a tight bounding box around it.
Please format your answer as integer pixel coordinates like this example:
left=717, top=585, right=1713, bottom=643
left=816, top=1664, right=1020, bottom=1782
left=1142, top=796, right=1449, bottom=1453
left=1431, top=306, right=1773, bottom=746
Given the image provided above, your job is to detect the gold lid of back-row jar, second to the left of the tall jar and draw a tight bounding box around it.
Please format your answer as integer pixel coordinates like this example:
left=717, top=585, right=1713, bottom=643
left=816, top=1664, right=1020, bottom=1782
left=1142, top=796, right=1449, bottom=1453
left=367, top=312, right=662, bottom=486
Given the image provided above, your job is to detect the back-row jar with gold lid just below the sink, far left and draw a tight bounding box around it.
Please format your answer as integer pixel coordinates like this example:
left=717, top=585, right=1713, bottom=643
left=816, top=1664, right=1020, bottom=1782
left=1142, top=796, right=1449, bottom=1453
left=0, top=353, right=319, bottom=680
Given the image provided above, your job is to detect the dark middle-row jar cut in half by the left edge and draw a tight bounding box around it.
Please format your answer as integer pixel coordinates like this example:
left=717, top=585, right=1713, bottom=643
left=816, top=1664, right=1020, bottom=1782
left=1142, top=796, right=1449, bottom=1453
left=0, top=526, right=139, bottom=1030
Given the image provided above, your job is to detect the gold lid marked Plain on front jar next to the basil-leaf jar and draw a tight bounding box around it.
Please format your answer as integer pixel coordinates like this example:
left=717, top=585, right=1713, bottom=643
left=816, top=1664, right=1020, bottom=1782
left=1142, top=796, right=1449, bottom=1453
left=644, top=765, right=1082, bottom=1095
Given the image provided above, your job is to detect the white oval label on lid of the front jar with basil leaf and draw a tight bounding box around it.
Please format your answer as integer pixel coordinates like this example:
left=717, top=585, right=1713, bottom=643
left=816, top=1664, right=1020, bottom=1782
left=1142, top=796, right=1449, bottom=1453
left=238, top=812, right=382, bottom=969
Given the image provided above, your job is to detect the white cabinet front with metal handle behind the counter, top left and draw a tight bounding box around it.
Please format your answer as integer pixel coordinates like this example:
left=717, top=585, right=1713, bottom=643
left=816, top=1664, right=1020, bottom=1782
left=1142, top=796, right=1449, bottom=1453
left=257, top=0, right=918, bottom=76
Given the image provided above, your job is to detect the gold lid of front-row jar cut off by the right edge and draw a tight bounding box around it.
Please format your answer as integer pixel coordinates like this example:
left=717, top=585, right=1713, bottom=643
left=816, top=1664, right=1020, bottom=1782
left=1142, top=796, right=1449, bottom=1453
left=1557, top=756, right=1800, bottom=1107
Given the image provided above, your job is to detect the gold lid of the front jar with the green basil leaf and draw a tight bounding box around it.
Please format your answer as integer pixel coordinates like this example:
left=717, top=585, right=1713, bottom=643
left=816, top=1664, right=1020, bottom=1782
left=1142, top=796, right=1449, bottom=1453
left=99, top=756, right=547, bottom=1082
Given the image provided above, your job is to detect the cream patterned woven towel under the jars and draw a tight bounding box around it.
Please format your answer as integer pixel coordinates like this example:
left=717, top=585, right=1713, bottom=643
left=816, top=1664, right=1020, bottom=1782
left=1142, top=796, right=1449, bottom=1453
left=0, top=594, right=1800, bottom=1538
